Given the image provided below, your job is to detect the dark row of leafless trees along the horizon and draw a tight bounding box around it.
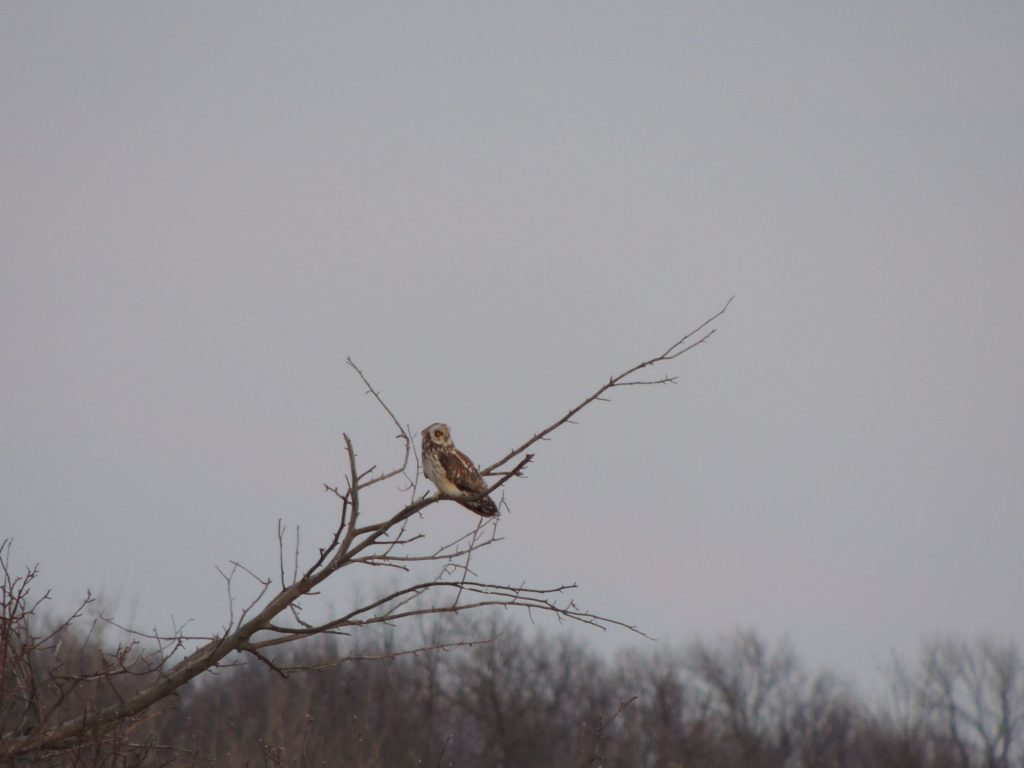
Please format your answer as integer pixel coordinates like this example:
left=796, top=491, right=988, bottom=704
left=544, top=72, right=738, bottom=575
left=9, top=612, right=1024, bottom=768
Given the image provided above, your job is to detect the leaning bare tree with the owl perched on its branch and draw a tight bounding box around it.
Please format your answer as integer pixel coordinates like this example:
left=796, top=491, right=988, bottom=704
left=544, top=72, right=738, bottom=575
left=0, top=299, right=731, bottom=762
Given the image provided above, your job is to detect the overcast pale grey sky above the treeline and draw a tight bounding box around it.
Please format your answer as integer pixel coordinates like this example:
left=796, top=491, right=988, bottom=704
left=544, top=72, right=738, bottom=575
left=0, top=2, right=1024, bottom=675
